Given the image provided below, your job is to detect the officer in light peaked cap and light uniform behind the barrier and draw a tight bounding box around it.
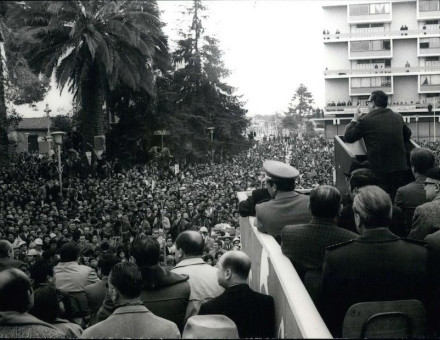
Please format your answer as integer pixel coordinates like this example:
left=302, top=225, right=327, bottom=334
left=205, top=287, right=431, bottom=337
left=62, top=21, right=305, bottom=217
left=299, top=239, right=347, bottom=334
left=255, top=161, right=312, bottom=240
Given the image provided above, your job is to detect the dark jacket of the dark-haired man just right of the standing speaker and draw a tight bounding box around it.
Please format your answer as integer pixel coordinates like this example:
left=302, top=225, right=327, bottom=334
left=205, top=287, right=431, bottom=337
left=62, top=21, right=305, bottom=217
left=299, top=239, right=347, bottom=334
left=394, top=175, right=428, bottom=234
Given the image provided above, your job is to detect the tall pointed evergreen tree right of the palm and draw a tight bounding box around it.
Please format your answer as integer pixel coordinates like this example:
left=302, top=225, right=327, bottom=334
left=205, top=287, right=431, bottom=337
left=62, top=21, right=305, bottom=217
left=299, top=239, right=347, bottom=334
left=171, top=0, right=248, bottom=161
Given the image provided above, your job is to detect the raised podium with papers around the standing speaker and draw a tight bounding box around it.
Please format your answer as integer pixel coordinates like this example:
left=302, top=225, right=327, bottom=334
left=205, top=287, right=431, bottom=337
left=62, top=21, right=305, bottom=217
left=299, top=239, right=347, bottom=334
left=334, top=136, right=419, bottom=196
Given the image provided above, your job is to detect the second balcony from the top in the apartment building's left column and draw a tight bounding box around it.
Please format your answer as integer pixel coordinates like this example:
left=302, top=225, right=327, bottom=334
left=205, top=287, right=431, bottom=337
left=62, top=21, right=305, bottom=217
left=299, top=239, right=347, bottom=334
left=348, top=40, right=393, bottom=60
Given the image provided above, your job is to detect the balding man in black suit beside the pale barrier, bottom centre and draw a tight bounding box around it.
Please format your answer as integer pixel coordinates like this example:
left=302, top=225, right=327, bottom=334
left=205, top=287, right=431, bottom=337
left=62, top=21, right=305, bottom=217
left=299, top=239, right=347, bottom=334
left=199, top=251, right=275, bottom=338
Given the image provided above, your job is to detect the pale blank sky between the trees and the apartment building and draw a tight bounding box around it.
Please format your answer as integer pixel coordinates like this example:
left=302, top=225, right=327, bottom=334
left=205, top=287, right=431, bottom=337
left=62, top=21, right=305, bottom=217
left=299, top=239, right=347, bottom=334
left=17, top=0, right=325, bottom=117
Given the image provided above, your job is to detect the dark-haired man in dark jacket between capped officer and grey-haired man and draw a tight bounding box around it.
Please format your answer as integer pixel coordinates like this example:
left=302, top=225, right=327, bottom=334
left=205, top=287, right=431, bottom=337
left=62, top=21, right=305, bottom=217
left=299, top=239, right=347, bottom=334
left=281, top=185, right=358, bottom=286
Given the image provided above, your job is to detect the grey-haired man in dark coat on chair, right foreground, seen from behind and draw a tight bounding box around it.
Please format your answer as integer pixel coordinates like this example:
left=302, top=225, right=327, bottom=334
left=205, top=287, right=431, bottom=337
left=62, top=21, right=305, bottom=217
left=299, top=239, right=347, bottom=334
left=320, top=186, right=428, bottom=337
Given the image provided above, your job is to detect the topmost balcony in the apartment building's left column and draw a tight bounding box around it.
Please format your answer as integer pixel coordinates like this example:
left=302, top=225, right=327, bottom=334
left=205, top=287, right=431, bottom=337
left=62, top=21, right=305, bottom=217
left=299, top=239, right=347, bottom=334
left=347, top=2, right=392, bottom=24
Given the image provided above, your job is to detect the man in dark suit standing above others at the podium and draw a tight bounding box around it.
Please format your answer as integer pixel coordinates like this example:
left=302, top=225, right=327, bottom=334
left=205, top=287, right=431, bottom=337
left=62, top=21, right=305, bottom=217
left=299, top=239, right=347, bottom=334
left=344, top=91, right=411, bottom=199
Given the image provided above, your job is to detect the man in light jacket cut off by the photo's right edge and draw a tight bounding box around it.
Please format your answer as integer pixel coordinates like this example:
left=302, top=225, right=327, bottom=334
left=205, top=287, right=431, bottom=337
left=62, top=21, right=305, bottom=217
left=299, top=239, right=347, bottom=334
left=408, top=166, right=440, bottom=240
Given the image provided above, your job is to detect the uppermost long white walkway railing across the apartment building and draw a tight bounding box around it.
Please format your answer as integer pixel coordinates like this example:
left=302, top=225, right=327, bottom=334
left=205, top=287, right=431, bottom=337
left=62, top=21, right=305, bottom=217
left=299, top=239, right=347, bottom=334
left=322, top=28, right=440, bottom=42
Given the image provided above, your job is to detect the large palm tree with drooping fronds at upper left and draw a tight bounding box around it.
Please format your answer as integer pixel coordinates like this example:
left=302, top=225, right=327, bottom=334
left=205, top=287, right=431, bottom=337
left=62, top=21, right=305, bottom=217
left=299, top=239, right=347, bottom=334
left=17, top=0, right=168, bottom=142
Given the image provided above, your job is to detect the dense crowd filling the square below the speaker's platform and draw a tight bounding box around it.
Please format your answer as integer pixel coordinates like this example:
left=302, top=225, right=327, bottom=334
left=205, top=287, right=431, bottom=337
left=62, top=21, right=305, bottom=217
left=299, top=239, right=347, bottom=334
left=0, top=130, right=440, bottom=337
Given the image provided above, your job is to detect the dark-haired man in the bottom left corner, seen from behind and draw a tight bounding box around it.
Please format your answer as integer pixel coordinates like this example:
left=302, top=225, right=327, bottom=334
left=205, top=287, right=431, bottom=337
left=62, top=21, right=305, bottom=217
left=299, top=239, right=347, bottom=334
left=0, top=268, right=66, bottom=339
